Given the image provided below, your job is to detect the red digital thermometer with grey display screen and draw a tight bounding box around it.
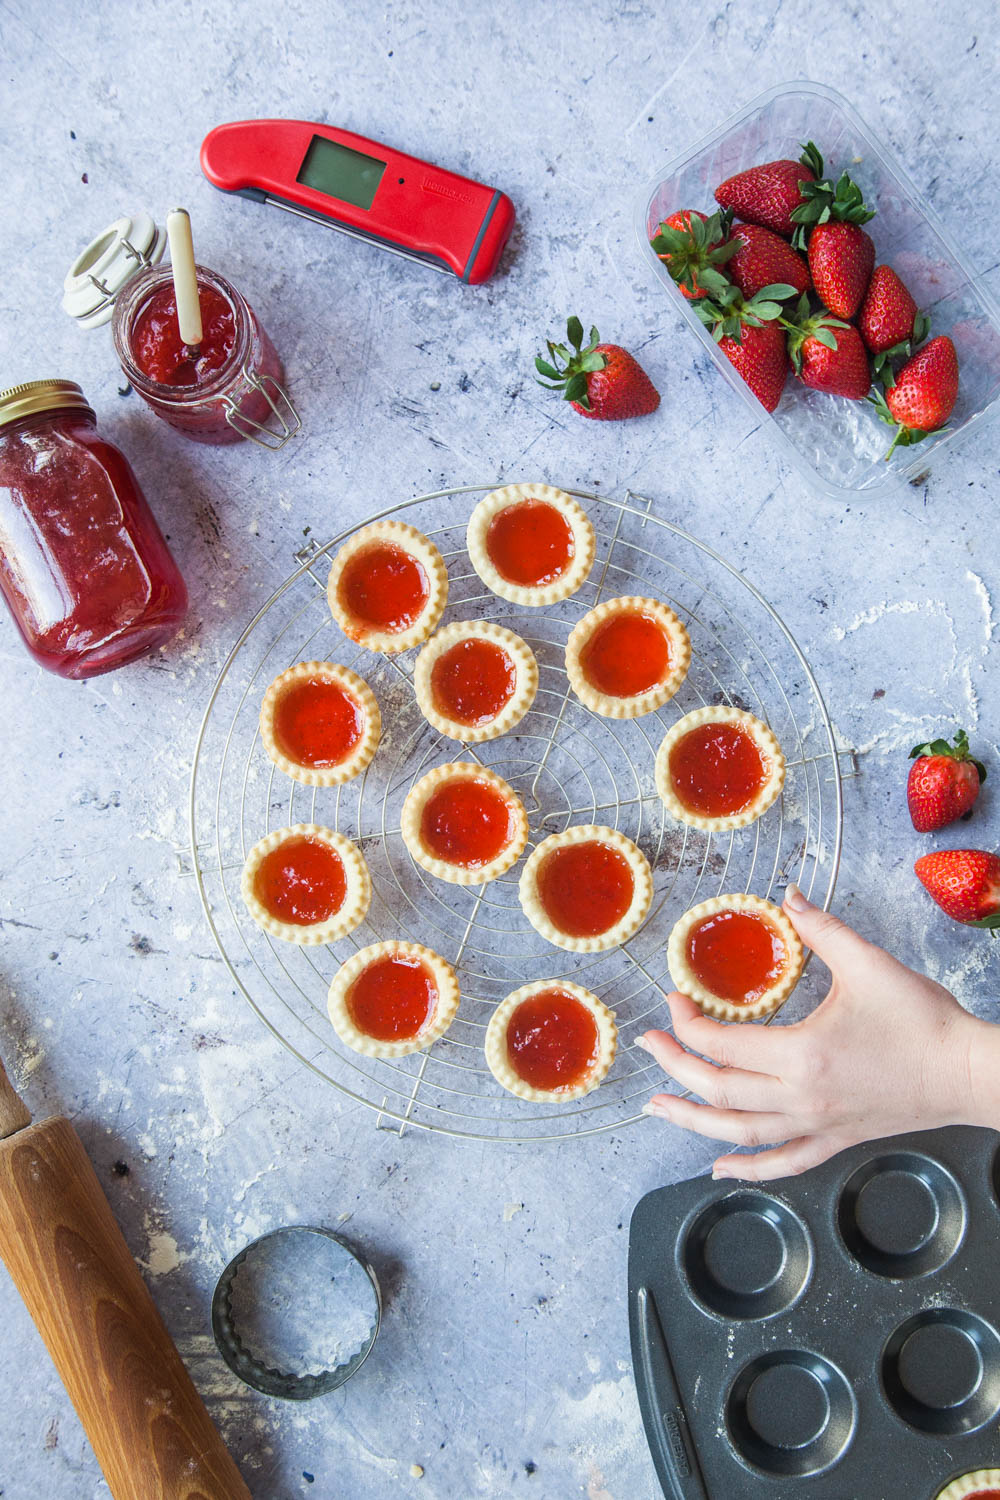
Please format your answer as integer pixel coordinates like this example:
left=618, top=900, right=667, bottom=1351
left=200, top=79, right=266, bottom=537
left=201, top=120, right=514, bottom=282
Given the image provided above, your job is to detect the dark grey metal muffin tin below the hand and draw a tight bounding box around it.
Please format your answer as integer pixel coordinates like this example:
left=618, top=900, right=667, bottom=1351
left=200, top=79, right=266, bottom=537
left=628, top=1127, right=1000, bottom=1500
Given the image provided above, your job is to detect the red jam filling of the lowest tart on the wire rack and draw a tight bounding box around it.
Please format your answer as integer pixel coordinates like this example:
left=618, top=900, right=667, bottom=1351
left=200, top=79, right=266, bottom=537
left=507, top=987, right=600, bottom=1092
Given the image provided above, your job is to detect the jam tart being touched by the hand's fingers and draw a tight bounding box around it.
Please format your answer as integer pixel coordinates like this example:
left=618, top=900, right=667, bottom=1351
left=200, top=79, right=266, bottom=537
left=667, top=894, right=802, bottom=1022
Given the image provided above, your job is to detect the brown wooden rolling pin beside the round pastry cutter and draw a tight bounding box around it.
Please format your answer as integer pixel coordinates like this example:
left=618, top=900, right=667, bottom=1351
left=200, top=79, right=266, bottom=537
left=0, top=1064, right=250, bottom=1500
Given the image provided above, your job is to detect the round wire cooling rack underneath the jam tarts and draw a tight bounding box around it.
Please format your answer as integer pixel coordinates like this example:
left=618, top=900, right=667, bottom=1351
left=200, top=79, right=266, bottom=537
left=190, top=486, right=843, bottom=1142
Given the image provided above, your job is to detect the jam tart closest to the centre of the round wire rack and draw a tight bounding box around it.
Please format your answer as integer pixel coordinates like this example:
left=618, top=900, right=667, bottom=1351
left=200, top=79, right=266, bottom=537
left=402, top=761, right=528, bottom=885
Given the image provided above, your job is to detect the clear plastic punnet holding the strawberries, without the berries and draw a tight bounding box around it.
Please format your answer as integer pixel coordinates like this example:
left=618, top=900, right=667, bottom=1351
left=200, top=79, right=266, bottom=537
left=636, top=83, right=1000, bottom=500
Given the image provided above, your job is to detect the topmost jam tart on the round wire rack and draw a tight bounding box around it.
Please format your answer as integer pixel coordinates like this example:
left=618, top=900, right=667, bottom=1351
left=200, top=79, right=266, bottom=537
left=465, top=485, right=595, bottom=608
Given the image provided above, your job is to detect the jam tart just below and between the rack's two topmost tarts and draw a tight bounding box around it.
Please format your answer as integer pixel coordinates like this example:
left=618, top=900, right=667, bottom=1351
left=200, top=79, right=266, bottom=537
left=414, top=620, right=538, bottom=744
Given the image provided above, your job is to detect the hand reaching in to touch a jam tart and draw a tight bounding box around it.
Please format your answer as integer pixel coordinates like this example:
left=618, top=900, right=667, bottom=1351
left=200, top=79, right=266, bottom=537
left=639, top=885, right=1000, bottom=1181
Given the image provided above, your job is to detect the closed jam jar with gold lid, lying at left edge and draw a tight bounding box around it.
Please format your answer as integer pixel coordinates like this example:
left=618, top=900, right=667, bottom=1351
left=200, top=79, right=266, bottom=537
left=0, top=380, right=187, bottom=678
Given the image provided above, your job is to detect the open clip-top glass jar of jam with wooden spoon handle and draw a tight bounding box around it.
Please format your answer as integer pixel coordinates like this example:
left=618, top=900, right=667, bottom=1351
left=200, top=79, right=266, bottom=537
left=111, top=266, right=300, bottom=449
